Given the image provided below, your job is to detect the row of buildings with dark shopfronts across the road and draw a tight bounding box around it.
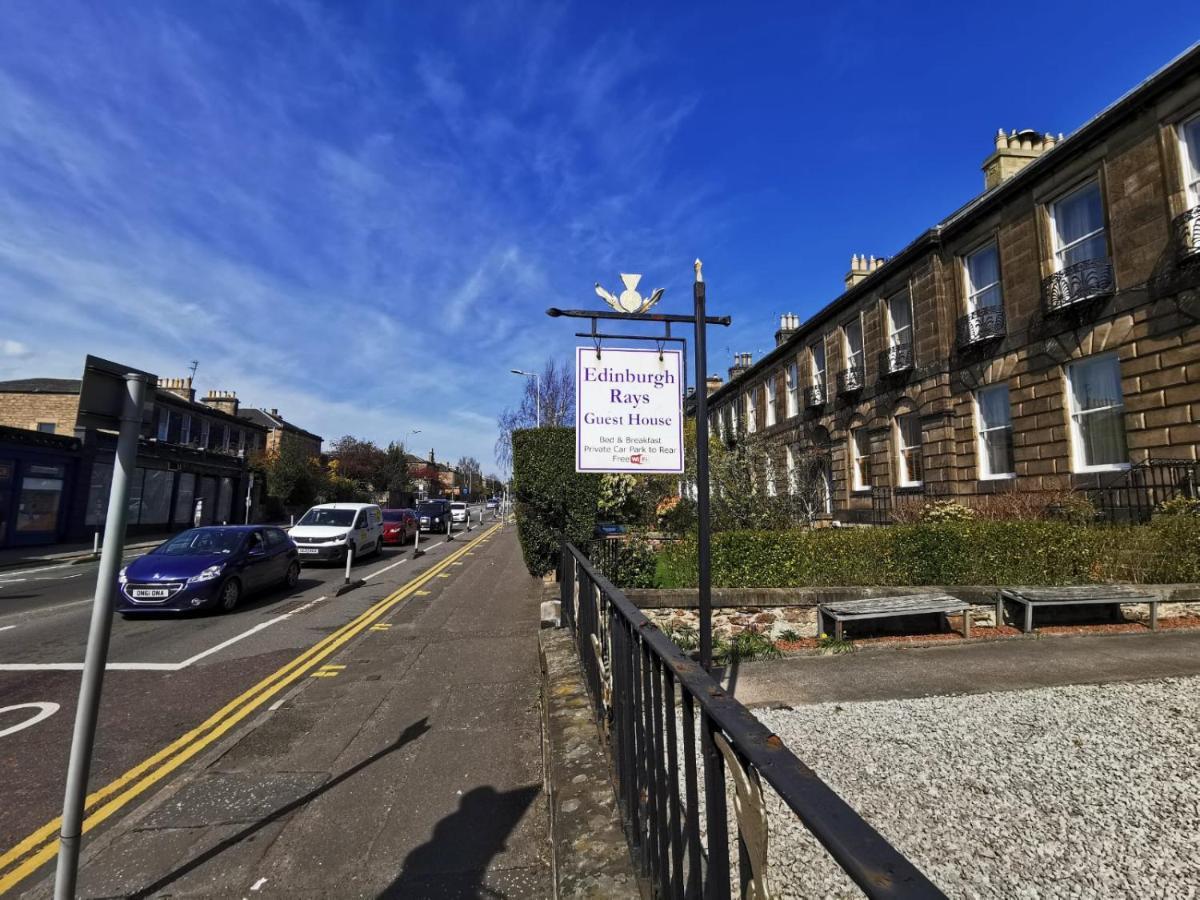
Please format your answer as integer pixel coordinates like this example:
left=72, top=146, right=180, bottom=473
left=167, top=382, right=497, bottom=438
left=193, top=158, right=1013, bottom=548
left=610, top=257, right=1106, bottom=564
left=0, top=362, right=266, bottom=547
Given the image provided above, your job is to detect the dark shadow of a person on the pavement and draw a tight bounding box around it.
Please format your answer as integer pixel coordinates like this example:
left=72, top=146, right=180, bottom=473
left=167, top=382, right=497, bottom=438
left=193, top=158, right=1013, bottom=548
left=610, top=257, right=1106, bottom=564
left=380, top=785, right=541, bottom=898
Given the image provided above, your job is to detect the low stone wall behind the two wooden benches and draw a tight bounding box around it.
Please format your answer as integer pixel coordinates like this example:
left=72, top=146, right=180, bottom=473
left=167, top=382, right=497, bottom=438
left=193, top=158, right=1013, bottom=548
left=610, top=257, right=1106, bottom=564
left=625, top=584, right=1200, bottom=640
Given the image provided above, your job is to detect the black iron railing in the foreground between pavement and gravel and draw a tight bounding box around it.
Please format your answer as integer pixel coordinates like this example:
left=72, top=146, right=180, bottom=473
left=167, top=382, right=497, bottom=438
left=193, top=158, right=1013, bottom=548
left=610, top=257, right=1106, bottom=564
left=559, top=544, right=943, bottom=898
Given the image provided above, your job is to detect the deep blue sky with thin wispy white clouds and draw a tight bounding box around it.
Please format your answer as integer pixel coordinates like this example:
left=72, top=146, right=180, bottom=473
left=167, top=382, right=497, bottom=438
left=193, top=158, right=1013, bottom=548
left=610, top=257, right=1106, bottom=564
left=0, top=0, right=1198, bottom=475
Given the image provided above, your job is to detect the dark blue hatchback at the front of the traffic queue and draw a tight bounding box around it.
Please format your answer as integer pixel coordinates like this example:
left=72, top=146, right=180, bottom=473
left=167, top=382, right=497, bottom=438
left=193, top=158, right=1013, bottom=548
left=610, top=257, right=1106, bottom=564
left=116, top=526, right=300, bottom=616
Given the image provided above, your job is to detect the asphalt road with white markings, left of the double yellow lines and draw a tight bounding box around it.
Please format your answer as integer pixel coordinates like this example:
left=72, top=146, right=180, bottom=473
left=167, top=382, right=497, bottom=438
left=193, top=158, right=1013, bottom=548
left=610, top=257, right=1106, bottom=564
left=0, top=508, right=491, bottom=893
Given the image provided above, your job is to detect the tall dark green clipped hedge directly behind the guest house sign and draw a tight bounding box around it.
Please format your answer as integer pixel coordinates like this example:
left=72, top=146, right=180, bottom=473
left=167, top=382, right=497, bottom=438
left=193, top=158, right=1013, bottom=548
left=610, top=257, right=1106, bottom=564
left=512, top=427, right=600, bottom=577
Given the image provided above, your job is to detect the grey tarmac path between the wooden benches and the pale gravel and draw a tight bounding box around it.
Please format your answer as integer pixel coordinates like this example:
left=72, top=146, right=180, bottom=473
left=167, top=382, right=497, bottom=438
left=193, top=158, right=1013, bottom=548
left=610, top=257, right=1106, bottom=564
left=722, top=630, right=1200, bottom=707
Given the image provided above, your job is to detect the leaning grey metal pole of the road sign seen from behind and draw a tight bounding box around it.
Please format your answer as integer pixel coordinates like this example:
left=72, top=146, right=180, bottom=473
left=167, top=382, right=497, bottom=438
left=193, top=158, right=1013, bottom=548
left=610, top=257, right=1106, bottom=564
left=54, top=374, right=146, bottom=900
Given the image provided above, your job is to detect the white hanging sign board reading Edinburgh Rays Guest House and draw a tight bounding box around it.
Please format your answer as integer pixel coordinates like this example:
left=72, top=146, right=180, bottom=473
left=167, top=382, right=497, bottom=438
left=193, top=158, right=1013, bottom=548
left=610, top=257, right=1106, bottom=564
left=575, top=347, right=684, bottom=474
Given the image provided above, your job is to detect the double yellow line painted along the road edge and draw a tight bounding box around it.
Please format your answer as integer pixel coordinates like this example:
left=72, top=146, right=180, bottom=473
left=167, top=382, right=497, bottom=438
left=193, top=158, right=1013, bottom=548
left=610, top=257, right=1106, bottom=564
left=0, top=524, right=500, bottom=894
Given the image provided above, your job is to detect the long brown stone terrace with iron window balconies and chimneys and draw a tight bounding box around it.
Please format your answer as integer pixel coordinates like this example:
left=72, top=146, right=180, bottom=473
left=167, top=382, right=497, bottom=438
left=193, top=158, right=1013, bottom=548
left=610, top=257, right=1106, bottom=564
left=709, top=48, right=1200, bottom=521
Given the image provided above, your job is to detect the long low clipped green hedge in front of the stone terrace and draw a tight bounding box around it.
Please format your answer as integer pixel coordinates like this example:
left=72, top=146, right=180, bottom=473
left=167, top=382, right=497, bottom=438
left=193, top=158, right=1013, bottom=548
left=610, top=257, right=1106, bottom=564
left=658, top=516, right=1200, bottom=588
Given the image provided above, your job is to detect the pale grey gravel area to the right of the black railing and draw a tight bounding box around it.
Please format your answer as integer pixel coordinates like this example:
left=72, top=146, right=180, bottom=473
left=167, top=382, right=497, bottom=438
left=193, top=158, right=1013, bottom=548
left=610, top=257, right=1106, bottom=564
left=757, top=678, right=1200, bottom=900
